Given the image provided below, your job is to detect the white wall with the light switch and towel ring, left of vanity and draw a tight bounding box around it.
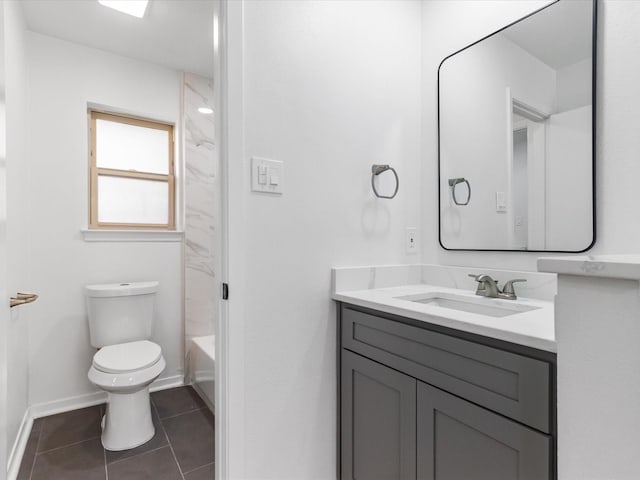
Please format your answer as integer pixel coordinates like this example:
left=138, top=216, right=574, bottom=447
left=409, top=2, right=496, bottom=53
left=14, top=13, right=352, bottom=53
left=229, top=0, right=422, bottom=479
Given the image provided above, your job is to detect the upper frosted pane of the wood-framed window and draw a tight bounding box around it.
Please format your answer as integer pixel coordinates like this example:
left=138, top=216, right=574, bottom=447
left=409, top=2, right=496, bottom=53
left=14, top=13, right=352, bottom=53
left=96, top=119, right=169, bottom=174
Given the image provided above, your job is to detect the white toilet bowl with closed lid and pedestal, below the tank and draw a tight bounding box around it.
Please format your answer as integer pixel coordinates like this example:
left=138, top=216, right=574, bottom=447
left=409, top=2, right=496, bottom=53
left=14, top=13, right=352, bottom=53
left=88, top=340, right=166, bottom=451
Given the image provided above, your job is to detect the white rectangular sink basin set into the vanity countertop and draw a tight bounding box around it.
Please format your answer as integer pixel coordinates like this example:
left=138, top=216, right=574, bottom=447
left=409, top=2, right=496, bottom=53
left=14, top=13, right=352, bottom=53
left=395, top=292, right=539, bottom=317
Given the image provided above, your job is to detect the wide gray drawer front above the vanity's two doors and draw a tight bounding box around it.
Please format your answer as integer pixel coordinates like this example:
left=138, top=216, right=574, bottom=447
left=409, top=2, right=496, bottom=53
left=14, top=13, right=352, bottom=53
left=342, top=306, right=551, bottom=433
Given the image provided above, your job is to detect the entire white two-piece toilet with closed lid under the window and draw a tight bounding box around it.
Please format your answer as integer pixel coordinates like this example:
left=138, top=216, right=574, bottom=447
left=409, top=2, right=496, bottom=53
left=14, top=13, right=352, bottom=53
left=85, top=282, right=166, bottom=450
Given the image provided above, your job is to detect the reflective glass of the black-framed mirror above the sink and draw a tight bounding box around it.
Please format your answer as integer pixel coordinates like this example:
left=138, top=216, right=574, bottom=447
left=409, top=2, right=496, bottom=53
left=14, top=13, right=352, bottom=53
left=438, top=0, right=595, bottom=252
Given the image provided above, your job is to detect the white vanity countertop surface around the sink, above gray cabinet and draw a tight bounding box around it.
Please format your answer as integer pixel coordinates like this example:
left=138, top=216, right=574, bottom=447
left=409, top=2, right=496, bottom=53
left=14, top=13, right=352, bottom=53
left=332, top=284, right=556, bottom=352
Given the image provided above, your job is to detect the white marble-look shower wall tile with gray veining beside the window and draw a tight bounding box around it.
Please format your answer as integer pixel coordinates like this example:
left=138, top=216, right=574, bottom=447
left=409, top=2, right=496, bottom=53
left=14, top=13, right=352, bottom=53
left=183, top=73, right=218, bottom=344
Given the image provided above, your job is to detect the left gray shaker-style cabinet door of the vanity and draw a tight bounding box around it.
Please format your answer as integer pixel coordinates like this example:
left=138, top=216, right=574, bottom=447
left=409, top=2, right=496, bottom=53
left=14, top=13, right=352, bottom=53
left=341, top=350, right=416, bottom=480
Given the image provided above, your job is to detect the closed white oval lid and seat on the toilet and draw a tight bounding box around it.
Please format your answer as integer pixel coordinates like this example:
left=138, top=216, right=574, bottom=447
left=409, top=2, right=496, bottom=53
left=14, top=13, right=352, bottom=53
left=93, top=340, right=162, bottom=374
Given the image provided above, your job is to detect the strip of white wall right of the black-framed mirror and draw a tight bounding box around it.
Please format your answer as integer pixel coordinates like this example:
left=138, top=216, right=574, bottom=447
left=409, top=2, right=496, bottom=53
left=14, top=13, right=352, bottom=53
left=593, top=0, right=640, bottom=253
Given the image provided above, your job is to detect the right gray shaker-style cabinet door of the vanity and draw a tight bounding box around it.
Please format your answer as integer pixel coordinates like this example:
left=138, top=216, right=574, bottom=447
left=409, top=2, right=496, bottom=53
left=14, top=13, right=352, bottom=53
left=417, top=382, right=551, bottom=480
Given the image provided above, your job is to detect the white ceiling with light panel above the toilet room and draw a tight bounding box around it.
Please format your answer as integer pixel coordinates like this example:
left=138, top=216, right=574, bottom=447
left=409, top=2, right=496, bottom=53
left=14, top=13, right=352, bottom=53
left=20, top=0, right=213, bottom=78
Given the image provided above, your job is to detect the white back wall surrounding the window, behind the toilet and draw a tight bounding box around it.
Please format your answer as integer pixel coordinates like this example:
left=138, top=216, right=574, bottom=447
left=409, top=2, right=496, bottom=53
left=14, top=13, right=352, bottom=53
left=22, top=33, right=183, bottom=404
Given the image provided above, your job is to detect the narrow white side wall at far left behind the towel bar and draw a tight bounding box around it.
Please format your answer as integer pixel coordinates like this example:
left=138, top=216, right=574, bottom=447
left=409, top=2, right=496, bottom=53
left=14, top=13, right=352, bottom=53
left=3, top=1, right=29, bottom=464
